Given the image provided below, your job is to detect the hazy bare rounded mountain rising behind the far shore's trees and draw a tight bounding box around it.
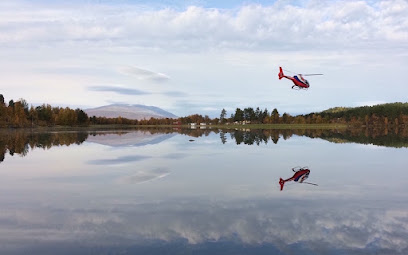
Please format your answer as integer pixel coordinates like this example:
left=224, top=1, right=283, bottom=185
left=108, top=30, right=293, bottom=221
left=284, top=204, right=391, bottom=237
left=84, top=104, right=177, bottom=120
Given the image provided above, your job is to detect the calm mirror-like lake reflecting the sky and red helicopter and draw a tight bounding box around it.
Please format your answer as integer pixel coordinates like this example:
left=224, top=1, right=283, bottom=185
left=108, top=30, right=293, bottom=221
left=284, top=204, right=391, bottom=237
left=0, top=128, right=408, bottom=254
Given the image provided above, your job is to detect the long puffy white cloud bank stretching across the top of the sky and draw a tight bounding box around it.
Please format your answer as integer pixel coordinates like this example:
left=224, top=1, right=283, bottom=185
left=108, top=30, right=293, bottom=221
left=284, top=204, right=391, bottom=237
left=0, top=0, right=408, bottom=50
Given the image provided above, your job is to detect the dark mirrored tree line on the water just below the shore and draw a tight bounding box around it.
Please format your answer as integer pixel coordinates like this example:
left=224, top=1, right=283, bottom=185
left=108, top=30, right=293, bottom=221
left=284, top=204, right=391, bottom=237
left=0, top=127, right=408, bottom=162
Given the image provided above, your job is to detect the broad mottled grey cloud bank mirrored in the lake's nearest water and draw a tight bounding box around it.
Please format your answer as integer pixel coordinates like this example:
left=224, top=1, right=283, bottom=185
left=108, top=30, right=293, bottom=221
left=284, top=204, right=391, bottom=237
left=0, top=200, right=408, bottom=254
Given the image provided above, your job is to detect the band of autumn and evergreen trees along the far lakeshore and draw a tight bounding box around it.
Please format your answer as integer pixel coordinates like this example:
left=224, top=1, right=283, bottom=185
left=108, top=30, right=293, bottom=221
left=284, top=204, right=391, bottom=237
left=0, top=94, right=408, bottom=129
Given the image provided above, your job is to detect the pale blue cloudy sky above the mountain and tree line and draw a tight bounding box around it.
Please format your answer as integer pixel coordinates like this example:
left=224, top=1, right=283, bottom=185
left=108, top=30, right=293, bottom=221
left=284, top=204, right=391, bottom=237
left=0, top=0, right=408, bottom=117
